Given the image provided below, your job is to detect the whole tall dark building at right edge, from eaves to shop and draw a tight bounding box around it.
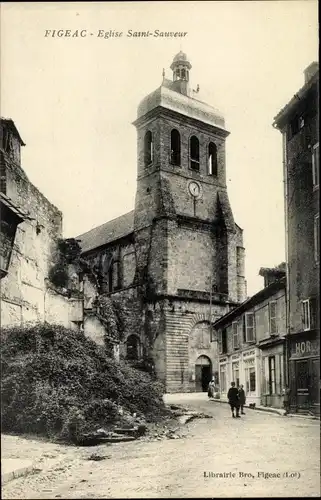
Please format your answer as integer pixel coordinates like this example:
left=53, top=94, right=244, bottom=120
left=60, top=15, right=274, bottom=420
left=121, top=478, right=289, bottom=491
left=274, top=63, right=320, bottom=413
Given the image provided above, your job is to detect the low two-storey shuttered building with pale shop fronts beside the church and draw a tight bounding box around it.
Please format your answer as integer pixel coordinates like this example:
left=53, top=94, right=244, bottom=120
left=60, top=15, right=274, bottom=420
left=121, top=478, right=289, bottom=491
left=213, top=268, right=286, bottom=408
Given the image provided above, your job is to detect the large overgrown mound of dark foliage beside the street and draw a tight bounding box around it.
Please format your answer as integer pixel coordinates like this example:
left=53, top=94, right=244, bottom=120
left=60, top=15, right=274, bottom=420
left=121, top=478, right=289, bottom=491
left=1, top=324, right=167, bottom=442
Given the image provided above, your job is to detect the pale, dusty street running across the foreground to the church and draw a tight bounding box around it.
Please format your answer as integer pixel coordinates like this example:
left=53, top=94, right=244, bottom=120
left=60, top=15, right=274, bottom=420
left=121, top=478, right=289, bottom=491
left=2, top=394, right=320, bottom=499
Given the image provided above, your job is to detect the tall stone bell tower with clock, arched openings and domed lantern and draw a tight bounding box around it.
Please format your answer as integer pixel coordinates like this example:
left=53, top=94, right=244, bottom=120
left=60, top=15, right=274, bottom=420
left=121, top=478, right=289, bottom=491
left=134, top=52, right=245, bottom=391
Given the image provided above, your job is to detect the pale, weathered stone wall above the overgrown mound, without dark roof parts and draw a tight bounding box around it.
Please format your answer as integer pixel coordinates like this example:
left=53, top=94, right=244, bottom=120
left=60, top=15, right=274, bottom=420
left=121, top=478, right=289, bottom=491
left=1, top=154, right=81, bottom=327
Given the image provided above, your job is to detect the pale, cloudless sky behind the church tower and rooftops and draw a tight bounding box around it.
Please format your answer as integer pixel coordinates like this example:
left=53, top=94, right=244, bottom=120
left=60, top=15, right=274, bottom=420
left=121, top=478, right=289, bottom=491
left=0, top=0, right=318, bottom=295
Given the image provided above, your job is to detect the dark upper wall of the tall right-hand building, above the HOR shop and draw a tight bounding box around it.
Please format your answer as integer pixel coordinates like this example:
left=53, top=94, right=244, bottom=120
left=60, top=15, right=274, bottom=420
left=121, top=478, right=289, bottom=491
left=286, top=94, right=320, bottom=333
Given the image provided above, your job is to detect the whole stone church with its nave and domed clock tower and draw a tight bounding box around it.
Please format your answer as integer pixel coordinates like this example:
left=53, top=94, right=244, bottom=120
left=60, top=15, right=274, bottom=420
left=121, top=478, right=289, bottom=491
left=77, top=51, right=246, bottom=392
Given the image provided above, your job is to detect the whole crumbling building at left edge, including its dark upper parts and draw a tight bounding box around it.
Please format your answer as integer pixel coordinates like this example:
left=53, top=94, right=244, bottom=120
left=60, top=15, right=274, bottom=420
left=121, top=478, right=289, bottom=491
left=0, top=118, right=82, bottom=328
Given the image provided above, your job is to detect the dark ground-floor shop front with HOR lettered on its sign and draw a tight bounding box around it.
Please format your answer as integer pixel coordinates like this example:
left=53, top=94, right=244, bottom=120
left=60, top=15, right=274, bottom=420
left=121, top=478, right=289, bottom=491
left=289, top=331, right=320, bottom=414
